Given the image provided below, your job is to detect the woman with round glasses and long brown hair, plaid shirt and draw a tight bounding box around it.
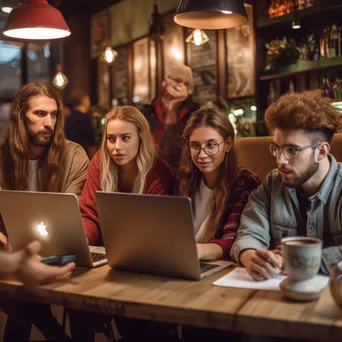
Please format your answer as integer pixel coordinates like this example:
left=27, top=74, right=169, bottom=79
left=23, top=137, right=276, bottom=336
left=179, top=107, right=260, bottom=260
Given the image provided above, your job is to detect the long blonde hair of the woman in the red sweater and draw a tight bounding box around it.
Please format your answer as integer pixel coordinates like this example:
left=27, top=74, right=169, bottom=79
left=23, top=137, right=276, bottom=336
left=100, top=106, right=157, bottom=194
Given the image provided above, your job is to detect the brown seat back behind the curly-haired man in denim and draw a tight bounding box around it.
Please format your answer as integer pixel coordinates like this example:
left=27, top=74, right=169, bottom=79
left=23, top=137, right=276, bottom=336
left=235, top=133, right=342, bottom=180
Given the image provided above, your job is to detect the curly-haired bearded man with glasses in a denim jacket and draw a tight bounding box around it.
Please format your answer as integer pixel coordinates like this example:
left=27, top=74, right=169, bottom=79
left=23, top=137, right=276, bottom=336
left=231, top=91, right=342, bottom=280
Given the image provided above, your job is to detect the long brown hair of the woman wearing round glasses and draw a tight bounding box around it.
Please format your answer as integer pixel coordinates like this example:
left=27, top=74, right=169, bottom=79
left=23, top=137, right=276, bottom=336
left=179, top=107, right=238, bottom=242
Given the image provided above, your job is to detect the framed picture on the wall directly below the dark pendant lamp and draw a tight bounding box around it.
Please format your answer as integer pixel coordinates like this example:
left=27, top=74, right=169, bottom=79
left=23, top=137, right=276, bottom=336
left=186, top=29, right=217, bottom=105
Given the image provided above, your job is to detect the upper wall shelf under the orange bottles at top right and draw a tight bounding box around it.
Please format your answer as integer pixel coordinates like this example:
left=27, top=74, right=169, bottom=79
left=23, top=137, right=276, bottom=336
left=257, top=0, right=342, bottom=29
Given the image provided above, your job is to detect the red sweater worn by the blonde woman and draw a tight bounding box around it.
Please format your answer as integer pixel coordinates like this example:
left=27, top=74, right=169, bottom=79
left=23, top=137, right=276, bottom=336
left=80, top=152, right=173, bottom=245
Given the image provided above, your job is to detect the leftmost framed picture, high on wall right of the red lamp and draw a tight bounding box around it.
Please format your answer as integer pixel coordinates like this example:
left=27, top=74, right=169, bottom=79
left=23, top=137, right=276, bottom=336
left=90, top=10, right=110, bottom=58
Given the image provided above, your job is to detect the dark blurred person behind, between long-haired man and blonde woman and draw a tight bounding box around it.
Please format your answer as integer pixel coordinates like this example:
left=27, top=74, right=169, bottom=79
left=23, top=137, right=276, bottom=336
left=65, top=89, right=97, bottom=159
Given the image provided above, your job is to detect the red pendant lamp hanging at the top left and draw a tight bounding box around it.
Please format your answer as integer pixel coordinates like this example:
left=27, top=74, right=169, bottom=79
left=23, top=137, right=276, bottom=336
left=3, top=0, right=71, bottom=40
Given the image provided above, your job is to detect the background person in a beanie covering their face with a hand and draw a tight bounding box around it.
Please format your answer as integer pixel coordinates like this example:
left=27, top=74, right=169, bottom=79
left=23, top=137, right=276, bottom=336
left=141, top=61, right=199, bottom=169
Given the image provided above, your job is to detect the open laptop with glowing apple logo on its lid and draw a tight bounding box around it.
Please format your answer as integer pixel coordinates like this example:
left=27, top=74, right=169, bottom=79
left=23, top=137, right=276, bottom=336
left=0, top=190, right=107, bottom=267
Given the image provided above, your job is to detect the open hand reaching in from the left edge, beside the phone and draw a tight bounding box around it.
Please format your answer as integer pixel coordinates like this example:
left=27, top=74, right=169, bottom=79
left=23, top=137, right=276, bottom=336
left=0, top=241, right=75, bottom=285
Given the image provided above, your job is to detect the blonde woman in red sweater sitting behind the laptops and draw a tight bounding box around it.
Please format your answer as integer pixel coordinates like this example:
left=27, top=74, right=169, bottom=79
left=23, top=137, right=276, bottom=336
left=80, top=106, right=173, bottom=245
